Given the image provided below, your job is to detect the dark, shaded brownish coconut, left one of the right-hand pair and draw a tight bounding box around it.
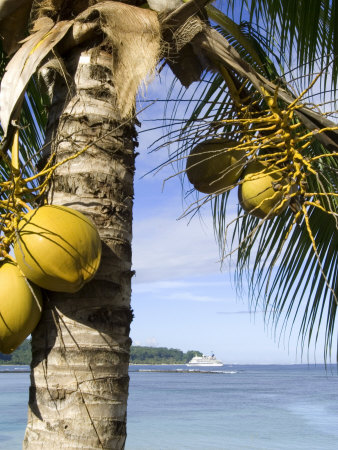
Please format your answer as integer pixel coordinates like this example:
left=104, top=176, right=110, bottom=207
left=186, top=139, right=245, bottom=194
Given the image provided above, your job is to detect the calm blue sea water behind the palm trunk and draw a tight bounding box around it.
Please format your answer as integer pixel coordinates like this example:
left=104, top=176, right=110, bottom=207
left=0, top=365, right=338, bottom=450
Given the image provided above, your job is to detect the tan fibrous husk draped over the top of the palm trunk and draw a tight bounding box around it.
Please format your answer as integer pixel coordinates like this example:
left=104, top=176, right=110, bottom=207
left=79, top=1, right=161, bottom=118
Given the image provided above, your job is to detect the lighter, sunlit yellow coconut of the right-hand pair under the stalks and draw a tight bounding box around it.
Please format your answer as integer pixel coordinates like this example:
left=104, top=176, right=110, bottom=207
left=238, top=161, right=289, bottom=219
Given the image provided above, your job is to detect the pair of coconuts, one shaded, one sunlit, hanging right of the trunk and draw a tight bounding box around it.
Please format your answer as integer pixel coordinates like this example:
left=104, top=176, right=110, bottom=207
left=186, top=139, right=289, bottom=219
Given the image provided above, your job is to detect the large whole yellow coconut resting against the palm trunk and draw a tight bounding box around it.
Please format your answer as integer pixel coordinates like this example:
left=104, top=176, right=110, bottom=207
left=14, top=205, right=101, bottom=292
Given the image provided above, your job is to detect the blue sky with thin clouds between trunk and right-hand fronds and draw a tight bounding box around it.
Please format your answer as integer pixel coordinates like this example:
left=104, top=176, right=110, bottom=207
left=131, top=72, right=323, bottom=364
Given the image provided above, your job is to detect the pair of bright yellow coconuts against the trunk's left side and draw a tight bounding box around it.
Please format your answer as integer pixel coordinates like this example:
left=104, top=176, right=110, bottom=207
left=0, top=205, right=101, bottom=353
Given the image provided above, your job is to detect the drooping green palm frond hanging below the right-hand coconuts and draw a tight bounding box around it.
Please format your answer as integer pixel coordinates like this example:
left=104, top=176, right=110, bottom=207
left=213, top=127, right=338, bottom=360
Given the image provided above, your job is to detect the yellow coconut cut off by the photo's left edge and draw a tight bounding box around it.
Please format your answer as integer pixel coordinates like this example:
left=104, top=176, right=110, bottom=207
left=0, top=262, right=42, bottom=353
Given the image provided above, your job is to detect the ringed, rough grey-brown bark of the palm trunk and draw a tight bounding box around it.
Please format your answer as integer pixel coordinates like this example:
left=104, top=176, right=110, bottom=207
left=24, top=44, right=136, bottom=450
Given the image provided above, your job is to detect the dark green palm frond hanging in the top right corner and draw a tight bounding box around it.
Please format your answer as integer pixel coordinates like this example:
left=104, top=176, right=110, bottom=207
left=245, top=0, right=338, bottom=89
